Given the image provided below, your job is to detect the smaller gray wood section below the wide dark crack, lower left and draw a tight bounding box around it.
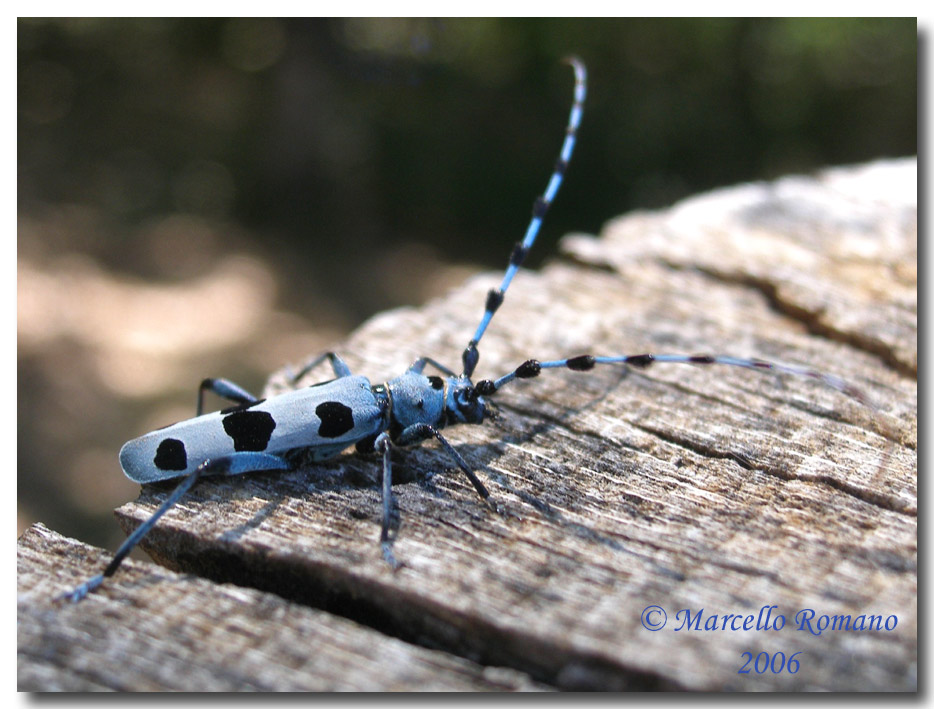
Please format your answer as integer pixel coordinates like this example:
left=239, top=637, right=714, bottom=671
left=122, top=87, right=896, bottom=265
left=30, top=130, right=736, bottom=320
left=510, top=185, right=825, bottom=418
left=17, top=525, right=538, bottom=692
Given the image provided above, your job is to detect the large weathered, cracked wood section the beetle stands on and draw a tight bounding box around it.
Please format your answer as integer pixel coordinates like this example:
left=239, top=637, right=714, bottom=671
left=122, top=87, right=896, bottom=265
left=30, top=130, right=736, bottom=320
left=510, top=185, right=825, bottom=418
left=21, top=160, right=917, bottom=690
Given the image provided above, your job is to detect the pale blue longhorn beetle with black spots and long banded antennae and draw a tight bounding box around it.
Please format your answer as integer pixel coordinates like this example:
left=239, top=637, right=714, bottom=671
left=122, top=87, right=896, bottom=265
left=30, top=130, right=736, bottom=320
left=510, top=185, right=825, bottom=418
left=61, top=58, right=871, bottom=601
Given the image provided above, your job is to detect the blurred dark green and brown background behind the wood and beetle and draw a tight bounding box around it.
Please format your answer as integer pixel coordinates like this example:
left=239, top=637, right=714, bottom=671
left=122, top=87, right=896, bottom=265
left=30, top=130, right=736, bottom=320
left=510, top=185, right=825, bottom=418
left=17, top=18, right=918, bottom=548
